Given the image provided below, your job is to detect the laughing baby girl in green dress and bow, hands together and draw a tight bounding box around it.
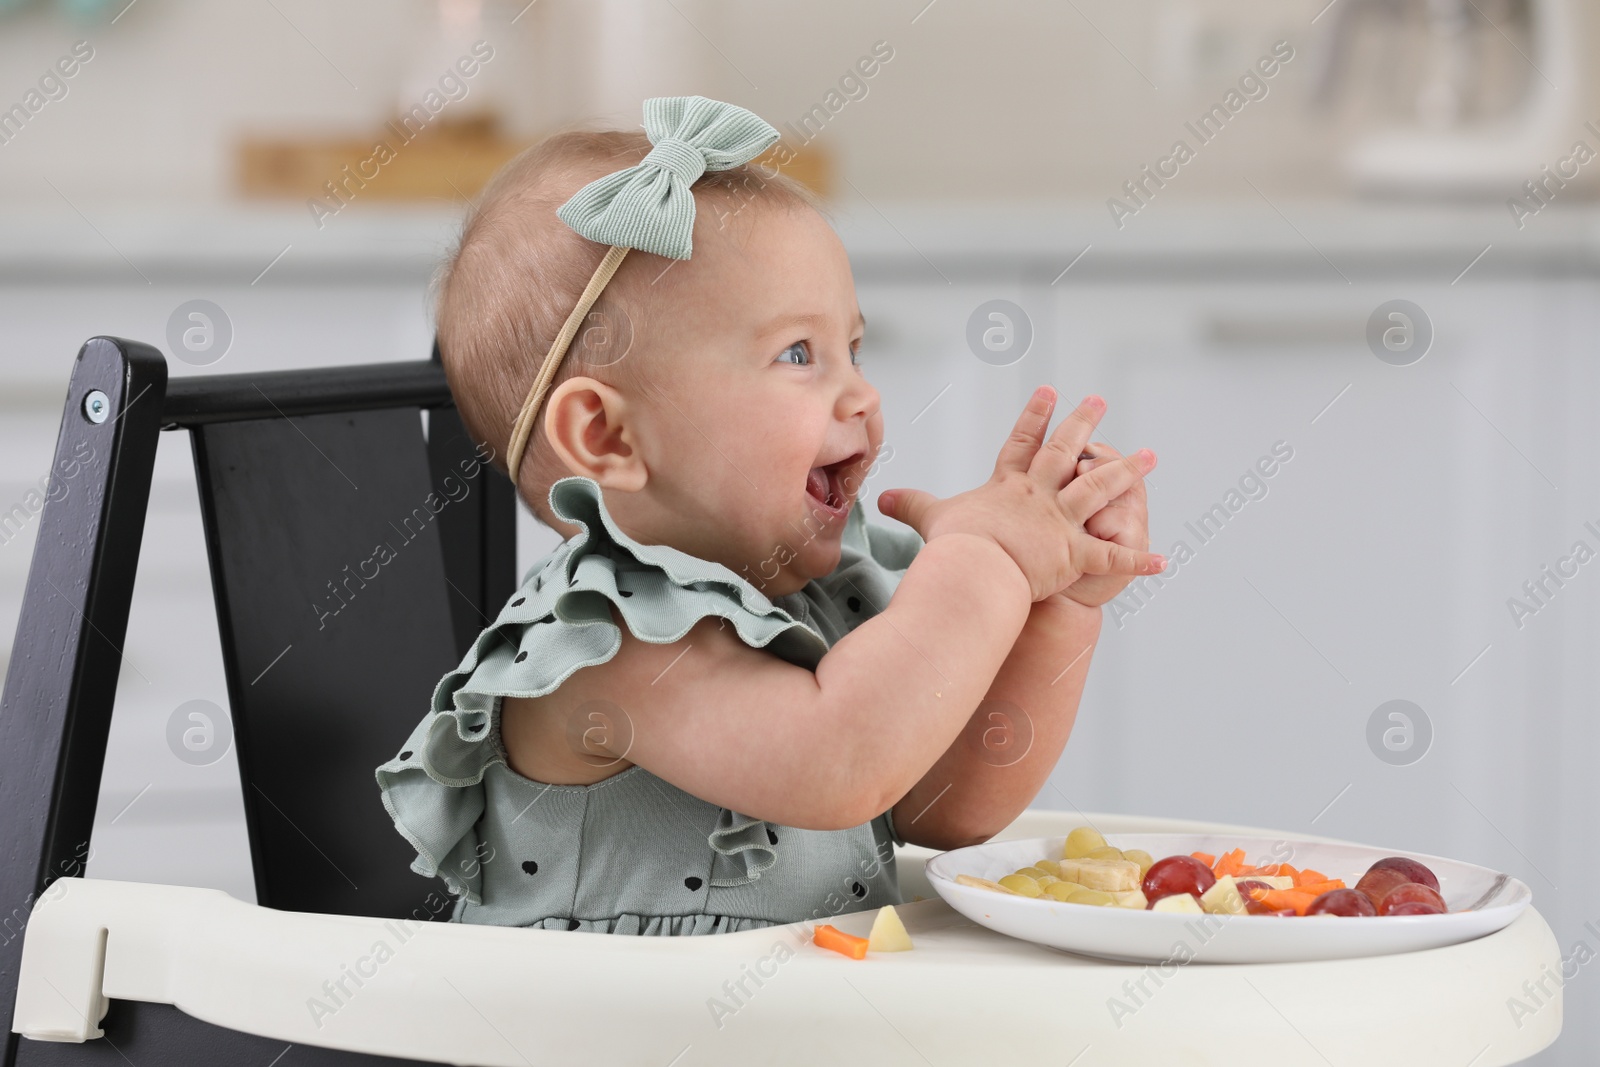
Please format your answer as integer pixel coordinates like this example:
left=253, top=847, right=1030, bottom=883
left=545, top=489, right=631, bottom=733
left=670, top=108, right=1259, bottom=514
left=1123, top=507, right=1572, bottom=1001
left=378, top=96, right=1165, bottom=934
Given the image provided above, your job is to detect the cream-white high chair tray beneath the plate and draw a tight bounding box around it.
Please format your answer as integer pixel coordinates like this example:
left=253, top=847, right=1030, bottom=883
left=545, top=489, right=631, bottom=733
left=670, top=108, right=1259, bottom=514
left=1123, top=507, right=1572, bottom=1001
left=13, top=811, right=1562, bottom=1067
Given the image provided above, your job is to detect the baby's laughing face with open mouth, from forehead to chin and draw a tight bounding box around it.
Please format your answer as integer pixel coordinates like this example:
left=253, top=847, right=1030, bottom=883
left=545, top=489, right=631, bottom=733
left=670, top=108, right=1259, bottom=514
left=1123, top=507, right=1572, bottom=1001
left=606, top=202, right=883, bottom=597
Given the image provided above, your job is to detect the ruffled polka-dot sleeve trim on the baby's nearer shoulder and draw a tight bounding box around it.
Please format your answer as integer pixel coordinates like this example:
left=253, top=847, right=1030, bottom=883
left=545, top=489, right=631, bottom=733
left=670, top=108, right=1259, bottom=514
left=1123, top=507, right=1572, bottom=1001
left=376, top=477, right=851, bottom=904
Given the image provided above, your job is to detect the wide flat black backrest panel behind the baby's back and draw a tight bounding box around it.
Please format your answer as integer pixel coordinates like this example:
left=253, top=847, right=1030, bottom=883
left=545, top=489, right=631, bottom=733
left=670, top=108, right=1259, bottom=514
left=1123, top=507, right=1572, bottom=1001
left=192, top=408, right=473, bottom=915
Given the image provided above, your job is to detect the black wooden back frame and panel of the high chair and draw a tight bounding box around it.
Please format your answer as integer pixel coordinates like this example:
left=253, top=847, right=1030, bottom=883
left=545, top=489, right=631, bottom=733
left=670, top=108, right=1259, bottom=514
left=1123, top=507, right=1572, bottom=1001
left=0, top=338, right=517, bottom=1065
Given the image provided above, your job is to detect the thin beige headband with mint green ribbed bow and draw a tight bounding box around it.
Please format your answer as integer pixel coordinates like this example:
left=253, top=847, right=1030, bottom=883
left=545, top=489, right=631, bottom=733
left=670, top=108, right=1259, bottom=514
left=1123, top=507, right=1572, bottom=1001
left=506, top=96, right=779, bottom=485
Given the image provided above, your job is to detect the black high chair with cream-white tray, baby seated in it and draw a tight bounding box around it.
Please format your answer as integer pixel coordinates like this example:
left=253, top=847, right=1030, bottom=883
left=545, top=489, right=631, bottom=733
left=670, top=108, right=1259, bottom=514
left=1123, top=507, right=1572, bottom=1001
left=0, top=338, right=1562, bottom=1067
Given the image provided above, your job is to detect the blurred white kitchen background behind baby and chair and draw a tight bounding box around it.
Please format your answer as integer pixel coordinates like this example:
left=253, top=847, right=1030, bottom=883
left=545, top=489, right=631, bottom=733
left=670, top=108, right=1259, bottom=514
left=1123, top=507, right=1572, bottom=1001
left=0, top=0, right=1600, bottom=1064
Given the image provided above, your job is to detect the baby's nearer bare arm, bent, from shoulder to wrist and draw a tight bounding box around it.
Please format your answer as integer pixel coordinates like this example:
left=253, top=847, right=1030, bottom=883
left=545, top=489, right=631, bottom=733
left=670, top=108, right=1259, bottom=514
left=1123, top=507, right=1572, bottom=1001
left=502, top=533, right=1030, bottom=830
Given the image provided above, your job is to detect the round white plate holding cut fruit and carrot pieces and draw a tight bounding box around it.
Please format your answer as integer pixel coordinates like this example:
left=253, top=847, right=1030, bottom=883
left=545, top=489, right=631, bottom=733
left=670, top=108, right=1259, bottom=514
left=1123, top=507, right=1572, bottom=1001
left=928, top=833, right=1533, bottom=963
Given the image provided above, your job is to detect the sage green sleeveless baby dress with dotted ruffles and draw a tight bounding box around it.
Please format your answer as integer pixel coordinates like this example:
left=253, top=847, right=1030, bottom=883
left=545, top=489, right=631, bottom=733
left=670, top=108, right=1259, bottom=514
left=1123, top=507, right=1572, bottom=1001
left=378, top=477, right=922, bottom=934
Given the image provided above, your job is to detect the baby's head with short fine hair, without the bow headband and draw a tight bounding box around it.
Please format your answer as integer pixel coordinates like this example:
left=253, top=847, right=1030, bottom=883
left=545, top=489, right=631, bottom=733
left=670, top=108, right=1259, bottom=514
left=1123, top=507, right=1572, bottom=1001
left=437, top=123, right=883, bottom=597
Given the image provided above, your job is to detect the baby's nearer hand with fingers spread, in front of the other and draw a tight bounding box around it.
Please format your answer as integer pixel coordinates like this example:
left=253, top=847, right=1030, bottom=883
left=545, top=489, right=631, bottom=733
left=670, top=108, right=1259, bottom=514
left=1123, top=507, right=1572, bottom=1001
left=878, top=386, right=1166, bottom=601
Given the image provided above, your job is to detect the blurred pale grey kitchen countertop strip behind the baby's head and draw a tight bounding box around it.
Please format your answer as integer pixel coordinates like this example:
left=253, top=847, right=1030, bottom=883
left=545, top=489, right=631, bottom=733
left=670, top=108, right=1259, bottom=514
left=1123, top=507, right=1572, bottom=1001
left=0, top=190, right=1600, bottom=286
